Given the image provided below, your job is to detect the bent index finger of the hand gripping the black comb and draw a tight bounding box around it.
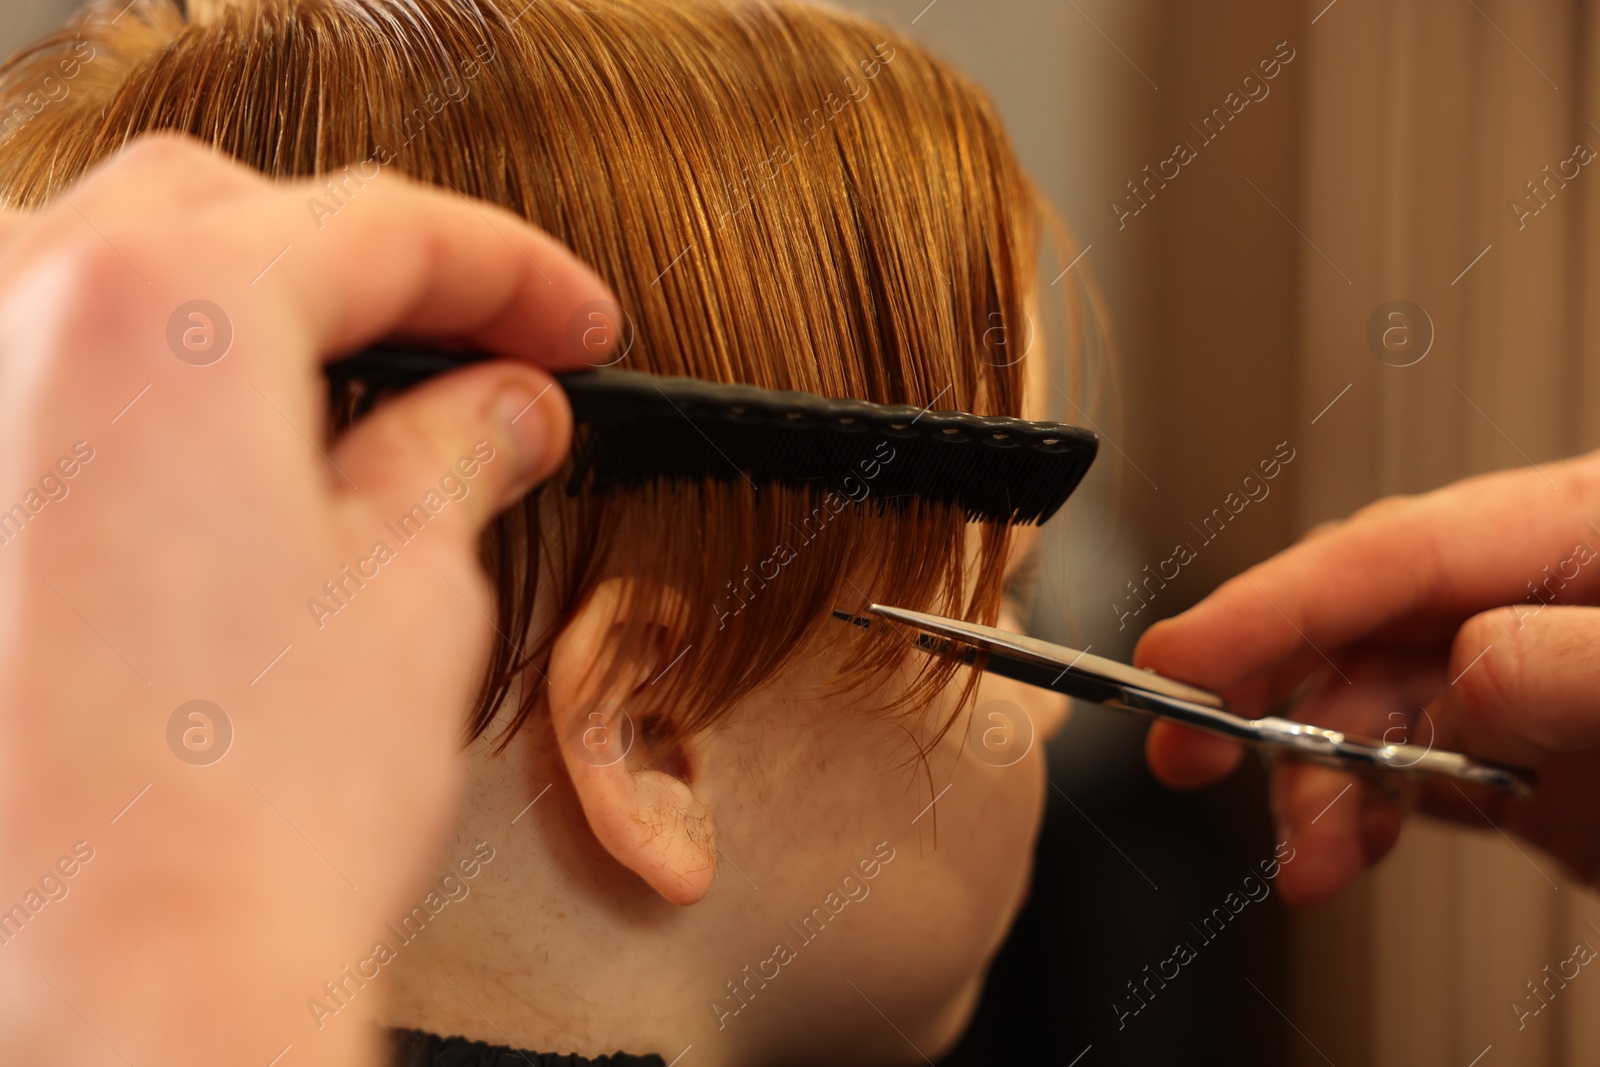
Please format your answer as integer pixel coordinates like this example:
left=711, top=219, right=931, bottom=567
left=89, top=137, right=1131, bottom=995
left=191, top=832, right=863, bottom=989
left=78, top=138, right=614, bottom=370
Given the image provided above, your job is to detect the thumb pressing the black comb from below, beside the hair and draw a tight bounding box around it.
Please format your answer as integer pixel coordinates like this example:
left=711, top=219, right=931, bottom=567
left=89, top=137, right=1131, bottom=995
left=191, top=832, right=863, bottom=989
left=330, top=363, right=573, bottom=545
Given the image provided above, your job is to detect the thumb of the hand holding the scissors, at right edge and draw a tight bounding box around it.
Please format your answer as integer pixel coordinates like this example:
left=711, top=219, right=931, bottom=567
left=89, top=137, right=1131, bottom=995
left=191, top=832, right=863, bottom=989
left=1434, top=605, right=1600, bottom=766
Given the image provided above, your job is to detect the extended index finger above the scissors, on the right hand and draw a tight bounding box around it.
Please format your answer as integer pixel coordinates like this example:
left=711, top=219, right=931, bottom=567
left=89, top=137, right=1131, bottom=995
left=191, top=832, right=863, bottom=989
left=1134, top=456, right=1600, bottom=691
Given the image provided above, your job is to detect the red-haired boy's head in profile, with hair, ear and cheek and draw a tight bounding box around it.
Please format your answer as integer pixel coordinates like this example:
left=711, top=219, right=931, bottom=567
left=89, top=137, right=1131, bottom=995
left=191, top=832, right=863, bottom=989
left=0, top=0, right=1075, bottom=1062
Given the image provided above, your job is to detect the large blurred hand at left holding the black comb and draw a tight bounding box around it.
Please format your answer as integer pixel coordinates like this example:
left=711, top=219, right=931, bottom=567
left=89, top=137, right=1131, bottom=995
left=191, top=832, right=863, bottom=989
left=0, top=138, right=606, bottom=1064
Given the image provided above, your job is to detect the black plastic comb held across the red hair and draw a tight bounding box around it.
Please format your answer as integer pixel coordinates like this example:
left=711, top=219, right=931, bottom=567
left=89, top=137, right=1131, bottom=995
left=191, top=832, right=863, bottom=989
left=326, top=346, right=1099, bottom=525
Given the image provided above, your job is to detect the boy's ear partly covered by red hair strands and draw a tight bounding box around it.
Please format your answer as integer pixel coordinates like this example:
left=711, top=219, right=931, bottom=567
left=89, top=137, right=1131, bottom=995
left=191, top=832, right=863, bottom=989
left=546, top=577, right=717, bottom=905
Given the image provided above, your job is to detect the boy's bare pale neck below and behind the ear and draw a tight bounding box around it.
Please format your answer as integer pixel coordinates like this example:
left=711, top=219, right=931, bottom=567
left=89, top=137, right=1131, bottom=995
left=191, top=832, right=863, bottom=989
left=382, top=728, right=749, bottom=1065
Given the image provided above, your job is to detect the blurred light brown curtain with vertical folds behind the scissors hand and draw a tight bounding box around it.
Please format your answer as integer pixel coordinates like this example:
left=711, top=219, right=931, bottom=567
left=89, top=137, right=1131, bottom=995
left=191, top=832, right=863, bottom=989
left=1290, top=0, right=1600, bottom=1067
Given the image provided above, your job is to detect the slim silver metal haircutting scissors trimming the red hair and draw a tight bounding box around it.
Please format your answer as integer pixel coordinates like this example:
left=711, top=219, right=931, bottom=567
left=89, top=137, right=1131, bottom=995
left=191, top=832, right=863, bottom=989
left=834, top=605, right=1536, bottom=797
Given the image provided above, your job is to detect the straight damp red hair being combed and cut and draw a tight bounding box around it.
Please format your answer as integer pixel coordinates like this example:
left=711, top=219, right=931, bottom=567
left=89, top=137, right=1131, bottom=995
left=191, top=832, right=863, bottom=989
left=0, top=0, right=1078, bottom=748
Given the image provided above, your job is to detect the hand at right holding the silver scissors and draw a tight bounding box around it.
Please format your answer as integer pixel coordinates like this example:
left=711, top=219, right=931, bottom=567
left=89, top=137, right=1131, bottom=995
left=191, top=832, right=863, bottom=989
left=1136, top=453, right=1600, bottom=904
